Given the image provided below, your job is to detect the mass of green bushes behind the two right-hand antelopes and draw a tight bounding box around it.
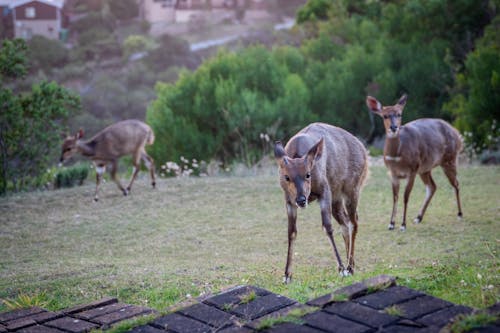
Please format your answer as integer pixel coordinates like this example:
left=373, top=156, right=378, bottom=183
left=147, top=0, right=500, bottom=165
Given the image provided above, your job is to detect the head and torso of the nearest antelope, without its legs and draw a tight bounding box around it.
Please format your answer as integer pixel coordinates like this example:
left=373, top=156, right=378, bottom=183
left=274, top=123, right=367, bottom=207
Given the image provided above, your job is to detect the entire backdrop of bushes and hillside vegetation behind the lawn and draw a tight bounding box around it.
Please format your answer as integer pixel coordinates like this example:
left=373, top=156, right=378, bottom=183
left=0, top=0, right=500, bottom=191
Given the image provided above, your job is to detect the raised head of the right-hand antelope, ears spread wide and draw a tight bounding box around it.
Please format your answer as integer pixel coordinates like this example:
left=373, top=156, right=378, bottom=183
left=366, top=94, right=407, bottom=138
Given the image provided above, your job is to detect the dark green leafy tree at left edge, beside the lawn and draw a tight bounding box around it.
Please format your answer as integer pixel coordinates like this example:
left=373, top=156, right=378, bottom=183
left=0, top=39, right=79, bottom=195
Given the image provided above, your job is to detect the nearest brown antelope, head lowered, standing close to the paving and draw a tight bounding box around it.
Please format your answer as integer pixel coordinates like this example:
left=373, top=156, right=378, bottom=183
left=274, top=123, right=368, bottom=283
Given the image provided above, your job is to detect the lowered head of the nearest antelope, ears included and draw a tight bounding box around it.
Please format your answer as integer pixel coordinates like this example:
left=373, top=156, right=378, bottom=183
left=274, top=138, right=324, bottom=208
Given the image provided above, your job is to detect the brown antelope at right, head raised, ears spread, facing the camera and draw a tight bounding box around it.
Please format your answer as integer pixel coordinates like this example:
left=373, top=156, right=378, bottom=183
left=366, top=95, right=462, bottom=231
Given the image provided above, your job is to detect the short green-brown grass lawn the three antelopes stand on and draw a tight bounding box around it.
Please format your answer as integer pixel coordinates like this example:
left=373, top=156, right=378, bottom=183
left=0, top=166, right=500, bottom=311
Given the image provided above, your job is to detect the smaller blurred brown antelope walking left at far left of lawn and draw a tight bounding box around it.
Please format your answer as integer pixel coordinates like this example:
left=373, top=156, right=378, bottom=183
left=61, top=120, right=156, bottom=201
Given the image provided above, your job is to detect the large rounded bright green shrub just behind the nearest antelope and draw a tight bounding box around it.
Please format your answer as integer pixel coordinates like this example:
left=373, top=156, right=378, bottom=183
left=147, top=46, right=317, bottom=165
